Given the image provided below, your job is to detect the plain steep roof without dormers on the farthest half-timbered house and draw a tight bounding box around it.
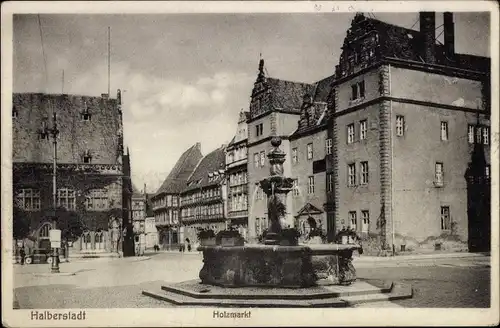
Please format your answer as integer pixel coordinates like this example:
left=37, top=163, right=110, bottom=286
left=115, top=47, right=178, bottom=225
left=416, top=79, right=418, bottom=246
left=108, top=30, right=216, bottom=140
left=156, top=143, right=203, bottom=195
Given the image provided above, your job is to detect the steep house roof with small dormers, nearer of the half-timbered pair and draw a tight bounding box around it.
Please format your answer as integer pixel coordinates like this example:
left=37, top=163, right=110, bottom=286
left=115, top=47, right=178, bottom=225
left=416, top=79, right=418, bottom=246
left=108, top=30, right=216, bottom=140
left=184, top=146, right=226, bottom=191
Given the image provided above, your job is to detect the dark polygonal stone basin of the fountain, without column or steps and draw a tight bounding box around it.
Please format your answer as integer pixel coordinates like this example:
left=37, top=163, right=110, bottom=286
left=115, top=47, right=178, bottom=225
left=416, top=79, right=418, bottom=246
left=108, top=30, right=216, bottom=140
left=198, top=244, right=360, bottom=288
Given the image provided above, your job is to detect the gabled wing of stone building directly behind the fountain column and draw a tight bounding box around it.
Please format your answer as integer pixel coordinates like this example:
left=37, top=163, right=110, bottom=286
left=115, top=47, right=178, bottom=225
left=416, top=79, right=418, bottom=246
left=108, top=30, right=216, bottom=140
left=247, top=60, right=314, bottom=240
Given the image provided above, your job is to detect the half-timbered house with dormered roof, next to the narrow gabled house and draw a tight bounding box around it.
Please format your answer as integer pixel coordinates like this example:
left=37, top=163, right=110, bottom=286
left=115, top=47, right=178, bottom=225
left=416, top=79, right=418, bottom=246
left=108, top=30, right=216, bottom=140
left=180, top=145, right=227, bottom=243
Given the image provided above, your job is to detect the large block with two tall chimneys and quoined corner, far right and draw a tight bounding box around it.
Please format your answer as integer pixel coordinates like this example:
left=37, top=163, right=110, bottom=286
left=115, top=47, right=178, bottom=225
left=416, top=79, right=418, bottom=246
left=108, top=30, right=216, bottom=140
left=332, top=12, right=490, bottom=249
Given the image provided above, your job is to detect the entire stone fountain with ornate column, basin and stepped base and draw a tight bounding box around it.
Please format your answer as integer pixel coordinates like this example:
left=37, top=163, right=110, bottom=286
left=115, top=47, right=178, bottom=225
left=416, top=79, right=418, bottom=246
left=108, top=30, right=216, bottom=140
left=143, top=137, right=411, bottom=307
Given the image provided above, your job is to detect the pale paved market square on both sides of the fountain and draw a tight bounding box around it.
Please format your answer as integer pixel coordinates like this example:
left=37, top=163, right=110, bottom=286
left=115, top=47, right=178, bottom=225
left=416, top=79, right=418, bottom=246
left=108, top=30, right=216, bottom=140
left=14, top=252, right=490, bottom=309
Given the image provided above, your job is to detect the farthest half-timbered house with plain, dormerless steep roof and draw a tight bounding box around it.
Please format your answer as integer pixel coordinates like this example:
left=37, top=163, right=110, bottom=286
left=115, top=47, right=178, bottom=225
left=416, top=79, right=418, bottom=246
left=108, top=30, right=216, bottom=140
left=151, top=143, right=203, bottom=249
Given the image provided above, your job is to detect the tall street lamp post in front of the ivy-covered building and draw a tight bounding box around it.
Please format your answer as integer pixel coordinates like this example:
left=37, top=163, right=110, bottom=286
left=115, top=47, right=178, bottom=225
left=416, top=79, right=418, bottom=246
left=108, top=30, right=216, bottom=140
left=42, top=106, right=59, bottom=273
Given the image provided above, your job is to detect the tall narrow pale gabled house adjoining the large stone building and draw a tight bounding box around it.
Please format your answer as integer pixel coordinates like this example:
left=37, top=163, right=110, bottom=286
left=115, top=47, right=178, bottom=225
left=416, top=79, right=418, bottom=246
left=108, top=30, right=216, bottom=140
left=226, top=110, right=249, bottom=239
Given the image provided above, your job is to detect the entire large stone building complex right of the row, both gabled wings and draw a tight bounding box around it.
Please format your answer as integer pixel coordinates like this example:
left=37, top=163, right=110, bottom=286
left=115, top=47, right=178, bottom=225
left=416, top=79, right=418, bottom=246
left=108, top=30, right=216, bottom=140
left=247, top=12, right=491, bottom=249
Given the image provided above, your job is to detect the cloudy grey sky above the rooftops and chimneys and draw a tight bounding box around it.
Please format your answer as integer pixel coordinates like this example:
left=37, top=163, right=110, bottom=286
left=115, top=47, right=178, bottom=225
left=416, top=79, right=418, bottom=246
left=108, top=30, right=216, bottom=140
left=13, top=13, right=489, bottom=192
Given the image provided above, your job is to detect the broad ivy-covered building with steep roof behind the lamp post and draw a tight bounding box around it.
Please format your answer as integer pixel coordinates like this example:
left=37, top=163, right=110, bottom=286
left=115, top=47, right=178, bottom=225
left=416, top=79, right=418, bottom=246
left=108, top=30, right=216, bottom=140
left=12, top=91, right=133, bottom=255
